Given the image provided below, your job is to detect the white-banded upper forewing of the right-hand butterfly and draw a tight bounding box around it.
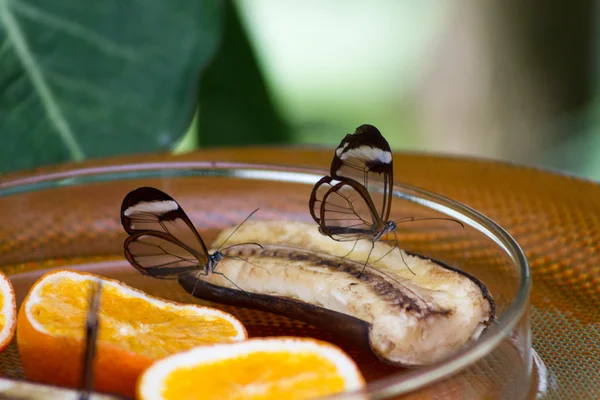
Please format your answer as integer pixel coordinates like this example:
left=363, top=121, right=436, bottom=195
left=330, top=125, right=394, bottom=221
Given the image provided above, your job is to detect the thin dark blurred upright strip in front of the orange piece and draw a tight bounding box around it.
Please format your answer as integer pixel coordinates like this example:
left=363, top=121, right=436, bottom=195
left=79, top=281, right=102, bottom=400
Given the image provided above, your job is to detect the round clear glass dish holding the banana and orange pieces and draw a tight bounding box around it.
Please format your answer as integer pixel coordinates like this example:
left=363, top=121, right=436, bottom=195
left=0, top=161, right=536, bottom=399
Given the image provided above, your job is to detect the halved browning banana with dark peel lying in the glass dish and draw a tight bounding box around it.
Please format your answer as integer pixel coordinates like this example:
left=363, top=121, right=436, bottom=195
left=180, top=221, right=495, bottom=366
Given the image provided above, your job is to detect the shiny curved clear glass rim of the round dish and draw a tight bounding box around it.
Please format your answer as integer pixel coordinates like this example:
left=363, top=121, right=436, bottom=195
left=0, top=161, right=531, bottom=399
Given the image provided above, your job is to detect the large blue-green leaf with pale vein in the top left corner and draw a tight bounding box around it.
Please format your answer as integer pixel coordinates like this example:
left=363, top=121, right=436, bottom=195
left=0, top=0, right=222, bottom=171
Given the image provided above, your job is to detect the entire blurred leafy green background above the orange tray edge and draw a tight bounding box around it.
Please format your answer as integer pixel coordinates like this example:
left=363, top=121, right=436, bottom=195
left=0, top=0, right=600, bottom=179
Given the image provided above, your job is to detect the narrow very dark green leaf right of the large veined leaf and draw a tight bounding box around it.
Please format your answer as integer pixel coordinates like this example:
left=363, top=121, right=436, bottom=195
left=197, top=1, right=290, bottom=147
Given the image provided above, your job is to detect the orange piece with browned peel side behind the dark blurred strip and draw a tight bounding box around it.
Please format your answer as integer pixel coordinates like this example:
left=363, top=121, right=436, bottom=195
left=17, top=270, right=247, bottom=397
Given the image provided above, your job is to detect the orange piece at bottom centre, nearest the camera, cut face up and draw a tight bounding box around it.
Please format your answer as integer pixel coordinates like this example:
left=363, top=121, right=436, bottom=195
left=137, top=337, right=364, bottom=400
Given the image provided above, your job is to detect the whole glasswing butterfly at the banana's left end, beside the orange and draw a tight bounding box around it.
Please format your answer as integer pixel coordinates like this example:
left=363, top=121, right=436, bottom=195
left=121, top=187, right=262, bottom=295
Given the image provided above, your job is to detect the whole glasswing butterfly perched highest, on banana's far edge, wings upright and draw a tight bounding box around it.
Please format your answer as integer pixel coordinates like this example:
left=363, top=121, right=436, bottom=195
left=309, top=124, right=462, bottom=277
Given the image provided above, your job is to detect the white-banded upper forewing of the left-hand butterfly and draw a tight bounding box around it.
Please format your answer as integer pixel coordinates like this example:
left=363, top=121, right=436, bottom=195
left=121, top=187, right=208, bottom=253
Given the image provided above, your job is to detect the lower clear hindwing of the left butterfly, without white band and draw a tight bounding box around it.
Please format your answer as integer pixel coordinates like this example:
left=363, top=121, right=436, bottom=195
left=124, top=231, right=209, bottom=279
